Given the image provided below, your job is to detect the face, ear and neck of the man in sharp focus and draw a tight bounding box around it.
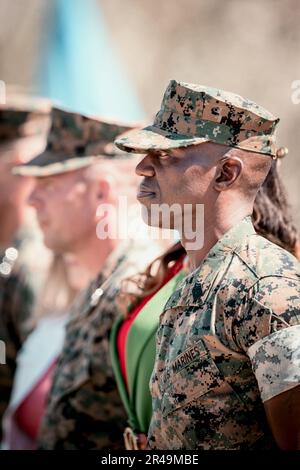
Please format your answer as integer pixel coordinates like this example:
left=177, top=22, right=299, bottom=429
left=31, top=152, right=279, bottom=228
left=136, top=142, right=271, bottom=269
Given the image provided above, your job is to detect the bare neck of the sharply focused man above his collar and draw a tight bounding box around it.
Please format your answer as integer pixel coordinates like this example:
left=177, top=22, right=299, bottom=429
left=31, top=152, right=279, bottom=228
left=181, top=200, right=252, bottom=271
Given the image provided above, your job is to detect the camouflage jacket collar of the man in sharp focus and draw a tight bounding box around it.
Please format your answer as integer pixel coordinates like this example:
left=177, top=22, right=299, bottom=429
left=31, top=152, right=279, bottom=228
left=164, top=216, right=256, bottom=312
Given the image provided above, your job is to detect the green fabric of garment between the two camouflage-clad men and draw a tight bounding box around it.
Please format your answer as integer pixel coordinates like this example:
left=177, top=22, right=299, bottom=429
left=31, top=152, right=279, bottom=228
left=110, top=271, right=185, bottom=433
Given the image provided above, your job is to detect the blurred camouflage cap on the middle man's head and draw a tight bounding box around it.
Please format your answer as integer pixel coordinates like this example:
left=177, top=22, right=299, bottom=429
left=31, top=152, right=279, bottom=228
left=13, top=107, right=133, bottom=177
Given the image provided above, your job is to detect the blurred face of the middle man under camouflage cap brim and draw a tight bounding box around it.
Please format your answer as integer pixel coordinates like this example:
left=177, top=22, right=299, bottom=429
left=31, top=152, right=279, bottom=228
left=29, top=169, right=98, bottom=253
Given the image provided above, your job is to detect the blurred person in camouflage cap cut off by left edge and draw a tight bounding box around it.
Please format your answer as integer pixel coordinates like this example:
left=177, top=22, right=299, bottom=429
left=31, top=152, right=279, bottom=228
left=0, top=93, right=50, bottom=437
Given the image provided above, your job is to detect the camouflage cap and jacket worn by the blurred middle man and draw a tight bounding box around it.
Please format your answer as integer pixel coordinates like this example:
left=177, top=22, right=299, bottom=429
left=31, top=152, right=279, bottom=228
left=15, top=108, right=158, bottom=450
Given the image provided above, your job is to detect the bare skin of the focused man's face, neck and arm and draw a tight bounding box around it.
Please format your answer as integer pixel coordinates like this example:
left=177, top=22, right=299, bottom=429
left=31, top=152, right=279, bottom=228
left=136, top=143, right=300, bottom=450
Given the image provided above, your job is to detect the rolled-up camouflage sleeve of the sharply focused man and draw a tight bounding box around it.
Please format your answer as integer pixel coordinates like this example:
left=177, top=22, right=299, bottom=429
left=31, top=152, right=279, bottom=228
left=235, top=277, right=300, bottom=401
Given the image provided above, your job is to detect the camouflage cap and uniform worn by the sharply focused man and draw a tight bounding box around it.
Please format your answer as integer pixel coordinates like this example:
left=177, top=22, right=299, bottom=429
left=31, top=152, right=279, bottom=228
left=116, top=81, right=300, bottom=450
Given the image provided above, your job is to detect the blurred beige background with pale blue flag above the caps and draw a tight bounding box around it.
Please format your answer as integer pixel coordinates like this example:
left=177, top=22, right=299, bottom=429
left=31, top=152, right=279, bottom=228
left=0, top=0, right=300, bottom=228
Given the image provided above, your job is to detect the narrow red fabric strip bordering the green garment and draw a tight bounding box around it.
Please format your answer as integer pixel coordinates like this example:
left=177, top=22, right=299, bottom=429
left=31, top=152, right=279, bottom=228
left=117, top=256, right=184, bottom=388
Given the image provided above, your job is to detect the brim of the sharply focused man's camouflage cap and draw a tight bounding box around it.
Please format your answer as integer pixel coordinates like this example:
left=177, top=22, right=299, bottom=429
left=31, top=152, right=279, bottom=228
left=115, top=126, right=209, bottom=153
